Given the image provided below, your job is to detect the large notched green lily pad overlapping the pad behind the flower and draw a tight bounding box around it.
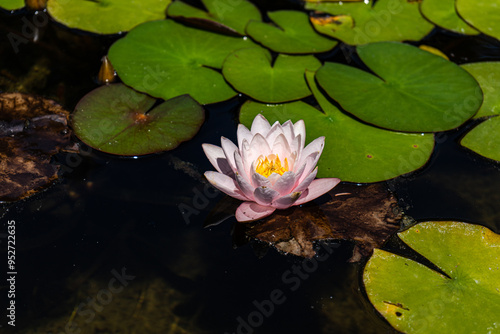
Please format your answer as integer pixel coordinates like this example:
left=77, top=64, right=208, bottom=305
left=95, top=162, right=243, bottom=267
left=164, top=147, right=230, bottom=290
left=316, top=42, right=482, bottom=132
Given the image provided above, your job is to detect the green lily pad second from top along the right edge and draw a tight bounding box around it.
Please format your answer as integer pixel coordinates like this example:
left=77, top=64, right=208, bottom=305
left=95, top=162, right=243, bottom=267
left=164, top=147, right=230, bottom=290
left=460, top=62, right=500, bottom=118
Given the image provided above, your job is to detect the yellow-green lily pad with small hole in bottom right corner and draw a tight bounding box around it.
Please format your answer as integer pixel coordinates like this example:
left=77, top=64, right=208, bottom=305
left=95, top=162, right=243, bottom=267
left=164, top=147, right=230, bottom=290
left=363, top=222, right=500, bottom=334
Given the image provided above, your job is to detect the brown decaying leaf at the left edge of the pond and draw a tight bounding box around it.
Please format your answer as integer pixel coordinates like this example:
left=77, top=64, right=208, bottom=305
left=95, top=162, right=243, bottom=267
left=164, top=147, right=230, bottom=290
left=0, top=93, right=70, bottom=201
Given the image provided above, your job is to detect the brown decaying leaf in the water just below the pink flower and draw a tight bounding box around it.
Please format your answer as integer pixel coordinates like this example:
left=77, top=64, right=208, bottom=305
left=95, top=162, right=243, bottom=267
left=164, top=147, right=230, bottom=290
left=240, top=184, right=403, bottom=262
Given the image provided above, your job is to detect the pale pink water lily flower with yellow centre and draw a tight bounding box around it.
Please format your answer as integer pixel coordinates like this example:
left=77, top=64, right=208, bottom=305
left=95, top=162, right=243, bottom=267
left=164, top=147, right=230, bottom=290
left=203, top=114, right=340, bottom=222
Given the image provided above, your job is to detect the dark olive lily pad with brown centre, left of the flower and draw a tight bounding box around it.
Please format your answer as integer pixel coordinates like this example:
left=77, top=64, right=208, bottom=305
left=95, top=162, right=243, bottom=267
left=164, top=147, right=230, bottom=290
left=72, top=84, right=205, bottom=156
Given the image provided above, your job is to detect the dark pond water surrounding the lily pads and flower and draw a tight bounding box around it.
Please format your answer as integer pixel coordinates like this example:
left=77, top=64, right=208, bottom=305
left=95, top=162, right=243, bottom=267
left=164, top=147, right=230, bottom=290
left=0, top=3, right=500, bottom=334
